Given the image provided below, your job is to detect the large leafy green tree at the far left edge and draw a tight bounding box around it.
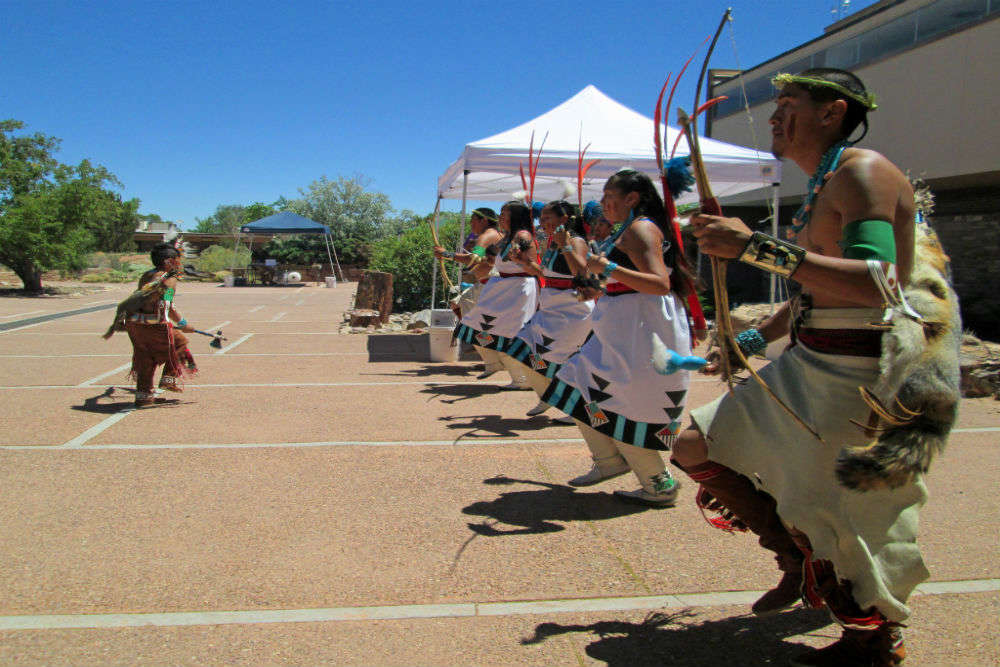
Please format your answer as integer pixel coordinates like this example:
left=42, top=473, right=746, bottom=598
left=0, top=119, right=138, bottom=291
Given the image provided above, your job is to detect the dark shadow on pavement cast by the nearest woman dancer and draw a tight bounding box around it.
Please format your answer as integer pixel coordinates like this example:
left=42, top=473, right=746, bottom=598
left=462, top=476, right=649, bottom=537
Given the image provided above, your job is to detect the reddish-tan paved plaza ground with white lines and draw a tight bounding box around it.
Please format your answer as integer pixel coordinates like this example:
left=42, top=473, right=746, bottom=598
left=0, top=283, right=1000, bottom=666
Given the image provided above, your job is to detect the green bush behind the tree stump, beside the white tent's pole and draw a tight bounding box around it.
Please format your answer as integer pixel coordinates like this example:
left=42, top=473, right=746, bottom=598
left=368, top=221, right=458, bottom=312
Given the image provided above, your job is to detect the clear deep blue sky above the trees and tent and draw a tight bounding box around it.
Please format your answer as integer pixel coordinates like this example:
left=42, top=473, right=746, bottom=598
left=0, top=0, right=873, bottom=228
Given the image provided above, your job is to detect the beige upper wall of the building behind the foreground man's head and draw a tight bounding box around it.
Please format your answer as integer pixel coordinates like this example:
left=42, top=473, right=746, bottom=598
left=711, top=7, right=1000, bottom=198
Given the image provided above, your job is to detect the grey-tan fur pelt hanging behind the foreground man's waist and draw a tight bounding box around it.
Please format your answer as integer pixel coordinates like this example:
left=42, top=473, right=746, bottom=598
left=836, top=224, right=962, bottom=491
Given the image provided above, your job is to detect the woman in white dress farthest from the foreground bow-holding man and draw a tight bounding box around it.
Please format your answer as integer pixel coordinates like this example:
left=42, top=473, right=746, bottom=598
left=446, top=201, right=538, bottom=389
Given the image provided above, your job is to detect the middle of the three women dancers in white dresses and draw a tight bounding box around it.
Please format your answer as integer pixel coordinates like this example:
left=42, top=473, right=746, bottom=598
left=500, top=201, right=594, bottom=423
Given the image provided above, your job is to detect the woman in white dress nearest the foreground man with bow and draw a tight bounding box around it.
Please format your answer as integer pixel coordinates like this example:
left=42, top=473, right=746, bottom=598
left=542, top=169, right=693, bottom=507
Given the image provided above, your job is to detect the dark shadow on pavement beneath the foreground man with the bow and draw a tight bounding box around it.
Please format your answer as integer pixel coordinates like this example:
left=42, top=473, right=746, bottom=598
left=521, top=609, right=836, bottom=667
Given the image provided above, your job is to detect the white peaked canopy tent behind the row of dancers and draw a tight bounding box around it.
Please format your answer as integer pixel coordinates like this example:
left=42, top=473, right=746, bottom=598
left=431, top=85, right=781, bottom=307
